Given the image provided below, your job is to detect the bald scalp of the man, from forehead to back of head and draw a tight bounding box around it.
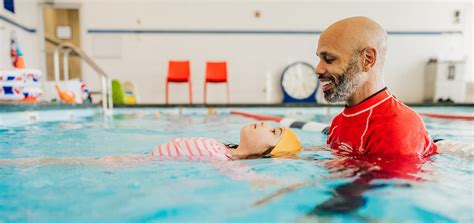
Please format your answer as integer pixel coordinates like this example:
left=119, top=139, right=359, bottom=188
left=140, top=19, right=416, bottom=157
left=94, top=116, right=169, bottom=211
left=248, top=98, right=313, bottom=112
left=319, top=16, right=387, bottom=67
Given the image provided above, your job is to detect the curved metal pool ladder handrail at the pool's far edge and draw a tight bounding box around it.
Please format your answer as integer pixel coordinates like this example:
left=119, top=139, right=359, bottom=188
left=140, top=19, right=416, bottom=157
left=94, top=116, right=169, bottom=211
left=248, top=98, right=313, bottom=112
left=45, top=36, right=113, bottom=114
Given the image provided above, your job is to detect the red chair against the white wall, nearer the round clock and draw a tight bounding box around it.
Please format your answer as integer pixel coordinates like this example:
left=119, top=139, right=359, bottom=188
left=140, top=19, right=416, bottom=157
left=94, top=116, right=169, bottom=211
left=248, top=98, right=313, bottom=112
left=204, top=61, right=229, bottom=104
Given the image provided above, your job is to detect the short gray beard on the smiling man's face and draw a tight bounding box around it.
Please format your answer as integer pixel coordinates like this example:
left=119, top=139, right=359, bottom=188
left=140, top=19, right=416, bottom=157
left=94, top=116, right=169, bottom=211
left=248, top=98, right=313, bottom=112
left=324, top=60, right=367, bottom=103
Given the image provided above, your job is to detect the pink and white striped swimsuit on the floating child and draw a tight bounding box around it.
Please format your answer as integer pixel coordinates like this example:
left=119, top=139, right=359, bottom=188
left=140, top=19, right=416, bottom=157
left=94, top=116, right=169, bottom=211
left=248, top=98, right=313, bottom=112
left=150, top=137, right=232, bottom=160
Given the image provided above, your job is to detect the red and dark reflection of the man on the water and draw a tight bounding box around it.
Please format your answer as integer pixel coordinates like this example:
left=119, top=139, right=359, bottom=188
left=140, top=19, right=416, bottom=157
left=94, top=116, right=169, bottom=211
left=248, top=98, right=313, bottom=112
left=307, top=156, right=426, bottom=220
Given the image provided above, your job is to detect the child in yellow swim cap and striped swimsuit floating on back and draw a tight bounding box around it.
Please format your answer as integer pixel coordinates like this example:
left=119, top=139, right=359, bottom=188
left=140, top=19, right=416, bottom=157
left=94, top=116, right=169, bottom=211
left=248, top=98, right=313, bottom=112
left=0, top=122, right=301, bottom=165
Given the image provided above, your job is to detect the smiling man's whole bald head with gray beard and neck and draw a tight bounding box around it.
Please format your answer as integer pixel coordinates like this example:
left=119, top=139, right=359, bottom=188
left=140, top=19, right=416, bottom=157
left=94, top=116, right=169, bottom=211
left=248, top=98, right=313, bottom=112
left=316, top=17, right=387, bottom=105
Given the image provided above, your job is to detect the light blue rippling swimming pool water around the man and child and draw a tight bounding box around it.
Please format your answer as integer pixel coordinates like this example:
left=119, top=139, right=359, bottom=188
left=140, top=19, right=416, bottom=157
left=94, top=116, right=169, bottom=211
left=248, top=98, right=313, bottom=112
left=0, top=107, right=474, bottom=222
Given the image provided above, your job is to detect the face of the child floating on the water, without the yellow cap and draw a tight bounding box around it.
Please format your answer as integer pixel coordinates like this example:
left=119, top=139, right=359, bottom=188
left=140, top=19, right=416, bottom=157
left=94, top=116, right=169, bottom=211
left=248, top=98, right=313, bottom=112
left=240, top=122, right=284, bottom=155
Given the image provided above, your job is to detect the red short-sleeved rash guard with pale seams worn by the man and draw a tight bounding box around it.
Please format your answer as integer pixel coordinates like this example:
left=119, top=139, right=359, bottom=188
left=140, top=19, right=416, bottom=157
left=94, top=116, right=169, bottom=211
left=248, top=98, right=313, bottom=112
left=327, top=88, right=436, bottom=158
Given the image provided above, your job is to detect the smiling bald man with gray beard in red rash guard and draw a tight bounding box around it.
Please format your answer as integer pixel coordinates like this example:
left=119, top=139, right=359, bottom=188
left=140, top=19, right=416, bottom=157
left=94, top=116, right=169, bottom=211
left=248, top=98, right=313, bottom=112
left=316, top=17, right=436, bottom=158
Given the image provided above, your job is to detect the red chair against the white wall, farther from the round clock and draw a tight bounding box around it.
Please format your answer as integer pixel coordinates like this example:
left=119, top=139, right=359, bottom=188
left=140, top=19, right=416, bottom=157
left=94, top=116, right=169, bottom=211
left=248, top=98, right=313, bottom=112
left=166, top=60, right=193, bottom=104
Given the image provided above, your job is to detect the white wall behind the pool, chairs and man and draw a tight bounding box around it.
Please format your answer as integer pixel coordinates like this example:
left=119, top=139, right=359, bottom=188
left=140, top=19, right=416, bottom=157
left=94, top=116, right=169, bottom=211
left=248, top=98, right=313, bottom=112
left=0, top=0, right=472, bottom=103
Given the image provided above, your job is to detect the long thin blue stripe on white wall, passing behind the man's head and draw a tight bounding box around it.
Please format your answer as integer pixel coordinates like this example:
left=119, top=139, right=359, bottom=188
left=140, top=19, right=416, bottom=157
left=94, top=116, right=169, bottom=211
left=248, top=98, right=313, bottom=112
left=87, top=29, right=462, bottom=35
